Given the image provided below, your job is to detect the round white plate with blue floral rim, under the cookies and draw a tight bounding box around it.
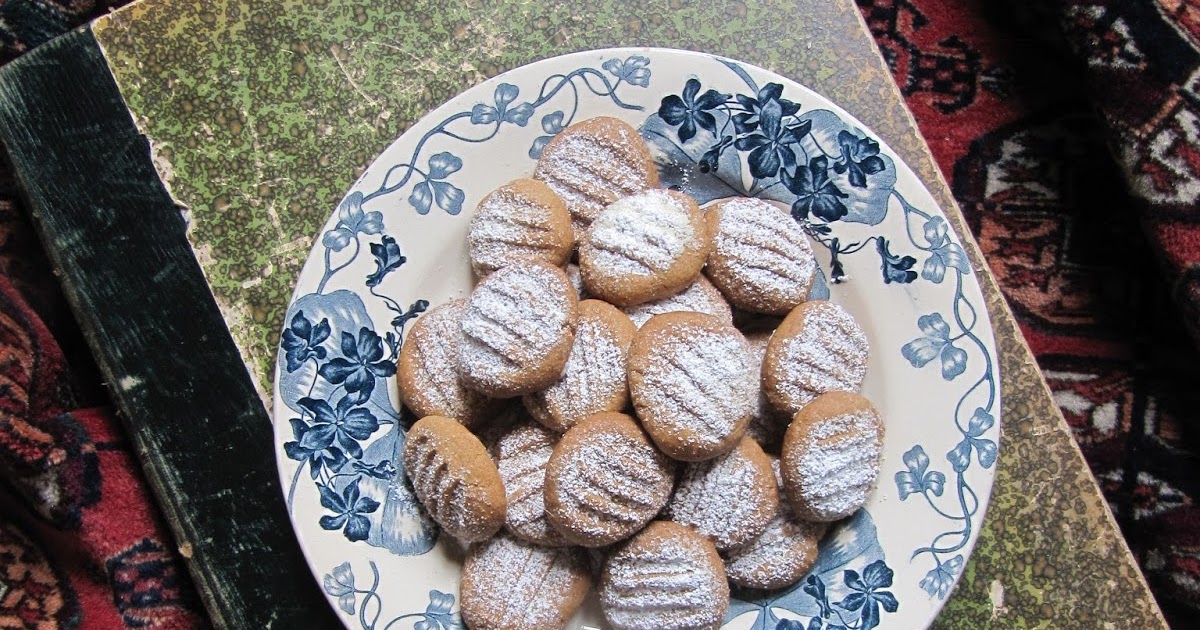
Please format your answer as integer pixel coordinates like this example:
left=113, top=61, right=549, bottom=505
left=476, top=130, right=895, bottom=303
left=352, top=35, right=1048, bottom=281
left=274, top=49, right=1000, bottom=630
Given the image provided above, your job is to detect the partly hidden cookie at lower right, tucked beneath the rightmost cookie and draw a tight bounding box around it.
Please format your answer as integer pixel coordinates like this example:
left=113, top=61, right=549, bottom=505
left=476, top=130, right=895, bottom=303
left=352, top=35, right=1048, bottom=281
left=724, top=457, right=828, bottom=590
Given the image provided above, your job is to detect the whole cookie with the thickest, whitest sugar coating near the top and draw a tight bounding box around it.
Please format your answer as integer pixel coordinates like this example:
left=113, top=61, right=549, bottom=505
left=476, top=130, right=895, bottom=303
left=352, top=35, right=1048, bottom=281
left=580, top=190, right=713, bottom=306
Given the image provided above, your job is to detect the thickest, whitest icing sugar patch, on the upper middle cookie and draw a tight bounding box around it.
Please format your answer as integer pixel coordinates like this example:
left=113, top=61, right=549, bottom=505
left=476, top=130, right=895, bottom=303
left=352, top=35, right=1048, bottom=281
left=582, top=190, right=701, bottom=276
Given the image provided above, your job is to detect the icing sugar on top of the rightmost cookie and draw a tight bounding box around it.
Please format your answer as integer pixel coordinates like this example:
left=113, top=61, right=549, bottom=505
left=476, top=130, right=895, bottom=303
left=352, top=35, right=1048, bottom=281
left=785, top=410, right=881, bottom=521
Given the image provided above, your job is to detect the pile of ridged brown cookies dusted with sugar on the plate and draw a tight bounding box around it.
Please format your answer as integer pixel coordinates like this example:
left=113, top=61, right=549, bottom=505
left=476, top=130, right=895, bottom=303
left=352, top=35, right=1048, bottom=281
left=398, top=118, right=883, bottom=630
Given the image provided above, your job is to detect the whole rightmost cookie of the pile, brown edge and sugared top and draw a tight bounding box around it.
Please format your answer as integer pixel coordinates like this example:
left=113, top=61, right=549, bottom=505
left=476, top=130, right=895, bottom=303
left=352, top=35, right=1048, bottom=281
left=779, top=391, right=883, bottom=522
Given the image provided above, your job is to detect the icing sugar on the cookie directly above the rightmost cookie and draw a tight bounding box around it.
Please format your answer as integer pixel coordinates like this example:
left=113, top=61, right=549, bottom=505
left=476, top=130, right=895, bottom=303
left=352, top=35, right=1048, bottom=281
left=774, top=302, right=868, bottom=412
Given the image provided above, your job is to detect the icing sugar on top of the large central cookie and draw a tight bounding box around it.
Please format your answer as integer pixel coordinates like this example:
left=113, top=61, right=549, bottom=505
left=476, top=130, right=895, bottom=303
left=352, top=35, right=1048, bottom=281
left=632, top=326, right=758, bottom=446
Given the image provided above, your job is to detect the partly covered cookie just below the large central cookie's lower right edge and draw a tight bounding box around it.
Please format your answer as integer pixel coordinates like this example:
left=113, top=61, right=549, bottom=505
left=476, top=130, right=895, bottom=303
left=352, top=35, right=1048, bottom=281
left=666, top=437, right=779, bottom=552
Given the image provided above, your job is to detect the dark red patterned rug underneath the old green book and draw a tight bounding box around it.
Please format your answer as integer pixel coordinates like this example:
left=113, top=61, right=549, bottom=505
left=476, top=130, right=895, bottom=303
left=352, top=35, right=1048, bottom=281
left=0, top=0, right=1200, bottom=629
